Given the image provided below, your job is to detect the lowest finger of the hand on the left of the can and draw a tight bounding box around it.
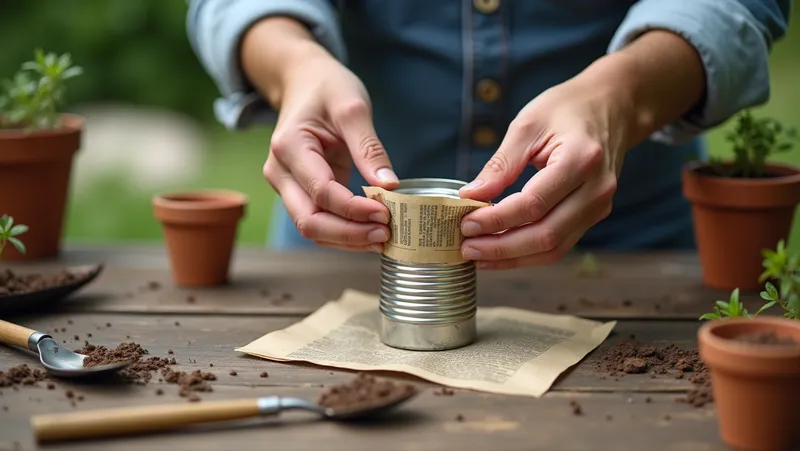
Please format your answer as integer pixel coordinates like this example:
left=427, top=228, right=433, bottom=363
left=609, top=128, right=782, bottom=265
left=281, top=173, right=390, bottom=246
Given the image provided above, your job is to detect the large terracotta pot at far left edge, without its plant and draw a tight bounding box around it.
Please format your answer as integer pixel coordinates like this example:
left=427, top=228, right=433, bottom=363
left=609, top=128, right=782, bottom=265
left=0, top=114, right=84, bottom=260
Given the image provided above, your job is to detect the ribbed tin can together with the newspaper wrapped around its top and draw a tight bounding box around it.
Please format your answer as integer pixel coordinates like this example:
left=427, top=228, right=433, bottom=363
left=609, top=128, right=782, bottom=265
left=364, top=179, right=489, bottom=351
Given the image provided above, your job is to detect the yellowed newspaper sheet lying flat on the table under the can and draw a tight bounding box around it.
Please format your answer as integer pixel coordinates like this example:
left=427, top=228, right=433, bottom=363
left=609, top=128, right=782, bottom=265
left=236, top=290, right=616, bottom=398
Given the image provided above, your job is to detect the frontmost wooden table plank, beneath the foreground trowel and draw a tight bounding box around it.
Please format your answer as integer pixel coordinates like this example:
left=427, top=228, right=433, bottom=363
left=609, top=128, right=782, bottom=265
left=0, top=385, right=726, bottom=451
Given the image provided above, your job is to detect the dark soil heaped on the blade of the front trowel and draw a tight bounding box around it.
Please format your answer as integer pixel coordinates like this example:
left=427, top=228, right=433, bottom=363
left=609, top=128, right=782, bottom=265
left=317, top=373, right=417, bottom=414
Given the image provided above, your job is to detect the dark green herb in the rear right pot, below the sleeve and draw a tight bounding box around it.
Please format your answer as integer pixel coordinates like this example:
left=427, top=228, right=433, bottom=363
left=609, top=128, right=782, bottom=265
left=709, top=110, right=797, bottom=178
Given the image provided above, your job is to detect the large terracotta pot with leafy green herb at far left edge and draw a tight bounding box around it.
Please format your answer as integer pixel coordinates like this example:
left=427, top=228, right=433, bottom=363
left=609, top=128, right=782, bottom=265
left=0, top=50, right=84, bottom=260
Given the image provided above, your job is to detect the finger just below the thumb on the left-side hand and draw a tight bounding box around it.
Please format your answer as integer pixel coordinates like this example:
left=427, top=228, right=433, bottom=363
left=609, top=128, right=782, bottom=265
left=271, top=131, right=389, bottom=224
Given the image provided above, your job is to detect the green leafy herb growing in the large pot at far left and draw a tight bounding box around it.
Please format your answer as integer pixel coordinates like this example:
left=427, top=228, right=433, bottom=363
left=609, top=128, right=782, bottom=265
left=0, top=49, right=83, bottom=130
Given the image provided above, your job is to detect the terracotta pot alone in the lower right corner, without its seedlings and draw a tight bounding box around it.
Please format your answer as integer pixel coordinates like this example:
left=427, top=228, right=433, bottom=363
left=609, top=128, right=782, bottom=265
left=698, top=317, right=800, bottom=451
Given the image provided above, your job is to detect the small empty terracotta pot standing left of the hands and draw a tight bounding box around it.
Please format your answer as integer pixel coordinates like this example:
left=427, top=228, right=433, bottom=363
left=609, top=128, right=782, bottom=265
left=153, top=191, right=247, bottom=286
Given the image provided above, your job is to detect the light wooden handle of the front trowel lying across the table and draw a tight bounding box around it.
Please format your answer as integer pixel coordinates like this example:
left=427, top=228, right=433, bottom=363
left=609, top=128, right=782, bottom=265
left=31, top=399, right=259, bottom=442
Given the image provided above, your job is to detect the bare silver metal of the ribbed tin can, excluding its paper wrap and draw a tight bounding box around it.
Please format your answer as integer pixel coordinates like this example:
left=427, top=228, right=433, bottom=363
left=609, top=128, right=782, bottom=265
left=379, top=178, right=477, bottom=351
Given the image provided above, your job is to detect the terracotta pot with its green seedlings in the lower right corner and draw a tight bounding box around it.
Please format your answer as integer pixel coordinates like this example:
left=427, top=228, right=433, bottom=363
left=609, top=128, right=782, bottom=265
left=698, top=241, right=800, bottom=450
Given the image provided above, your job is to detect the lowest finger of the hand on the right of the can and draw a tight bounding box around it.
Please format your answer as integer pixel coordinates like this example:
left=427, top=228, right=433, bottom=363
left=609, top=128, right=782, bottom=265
left=461, top=183, right=610, bottom=262
